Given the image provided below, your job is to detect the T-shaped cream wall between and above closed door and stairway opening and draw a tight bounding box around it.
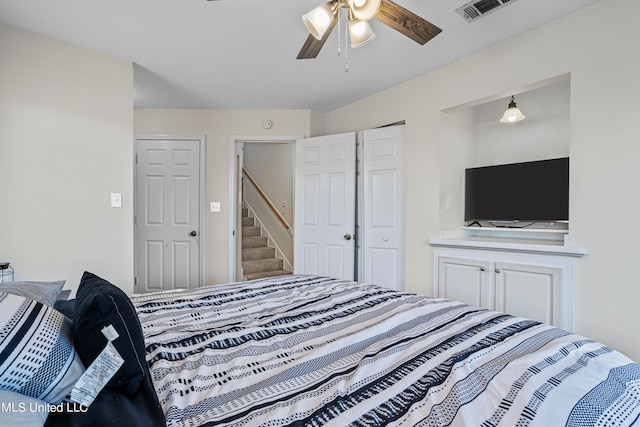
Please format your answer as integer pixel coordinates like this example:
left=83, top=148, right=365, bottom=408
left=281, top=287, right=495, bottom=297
left=134, top=109, right=310, bottom=284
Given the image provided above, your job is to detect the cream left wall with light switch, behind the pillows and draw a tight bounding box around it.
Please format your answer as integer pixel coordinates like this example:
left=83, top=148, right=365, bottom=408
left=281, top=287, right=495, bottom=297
left=0, top=23, right=133, bottom=292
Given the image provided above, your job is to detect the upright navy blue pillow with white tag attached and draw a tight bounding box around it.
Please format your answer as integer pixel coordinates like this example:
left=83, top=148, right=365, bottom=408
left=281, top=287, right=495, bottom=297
left=73, top=272, right=149, bottom=396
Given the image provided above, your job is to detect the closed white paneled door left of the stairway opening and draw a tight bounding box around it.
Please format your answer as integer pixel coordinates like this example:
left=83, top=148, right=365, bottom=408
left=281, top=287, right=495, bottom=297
left=135, top=138, right=203, bottom=292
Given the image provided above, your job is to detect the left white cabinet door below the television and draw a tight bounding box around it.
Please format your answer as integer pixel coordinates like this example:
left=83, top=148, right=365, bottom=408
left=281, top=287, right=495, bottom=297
left=438, top=257, right=491, bottom=308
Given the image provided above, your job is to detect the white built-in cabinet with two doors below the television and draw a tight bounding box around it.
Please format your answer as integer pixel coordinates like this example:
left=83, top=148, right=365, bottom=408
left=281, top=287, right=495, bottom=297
left=430, top=232, right=586, bottom=331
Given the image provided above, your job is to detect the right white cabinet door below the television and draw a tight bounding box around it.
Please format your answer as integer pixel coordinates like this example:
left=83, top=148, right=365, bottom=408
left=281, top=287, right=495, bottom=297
left=495, top=262, right=562, bottom=327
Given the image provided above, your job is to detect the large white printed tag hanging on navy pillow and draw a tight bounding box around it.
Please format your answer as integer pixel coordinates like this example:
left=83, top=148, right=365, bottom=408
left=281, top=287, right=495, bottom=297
left=71, top=342, right=124, bottom=407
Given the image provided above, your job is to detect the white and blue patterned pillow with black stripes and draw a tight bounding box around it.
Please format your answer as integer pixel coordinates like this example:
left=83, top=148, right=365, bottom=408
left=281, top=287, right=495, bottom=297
left=0, top=292, right=84, bottom=404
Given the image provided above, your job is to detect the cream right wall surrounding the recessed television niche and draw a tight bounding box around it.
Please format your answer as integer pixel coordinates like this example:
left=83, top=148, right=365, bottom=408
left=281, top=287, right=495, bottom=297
left=328, top=0, right=640, bottom=360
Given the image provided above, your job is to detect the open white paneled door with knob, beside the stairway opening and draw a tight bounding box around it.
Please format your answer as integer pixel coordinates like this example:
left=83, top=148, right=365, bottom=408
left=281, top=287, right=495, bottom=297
left=294, top=133, right=356, bottom=280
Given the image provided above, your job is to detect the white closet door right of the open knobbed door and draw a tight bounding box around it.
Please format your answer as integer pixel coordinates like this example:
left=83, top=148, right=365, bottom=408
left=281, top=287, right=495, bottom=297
left=358, top=126, right=405, bottom=291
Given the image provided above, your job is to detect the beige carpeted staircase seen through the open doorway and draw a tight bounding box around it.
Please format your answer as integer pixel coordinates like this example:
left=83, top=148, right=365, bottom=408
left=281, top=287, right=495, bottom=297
left=242, top=208, right=291, bottom=280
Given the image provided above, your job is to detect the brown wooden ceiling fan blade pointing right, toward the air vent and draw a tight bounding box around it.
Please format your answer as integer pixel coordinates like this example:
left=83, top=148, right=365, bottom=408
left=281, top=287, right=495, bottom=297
left=375, top=0, right=442, bottom=44
